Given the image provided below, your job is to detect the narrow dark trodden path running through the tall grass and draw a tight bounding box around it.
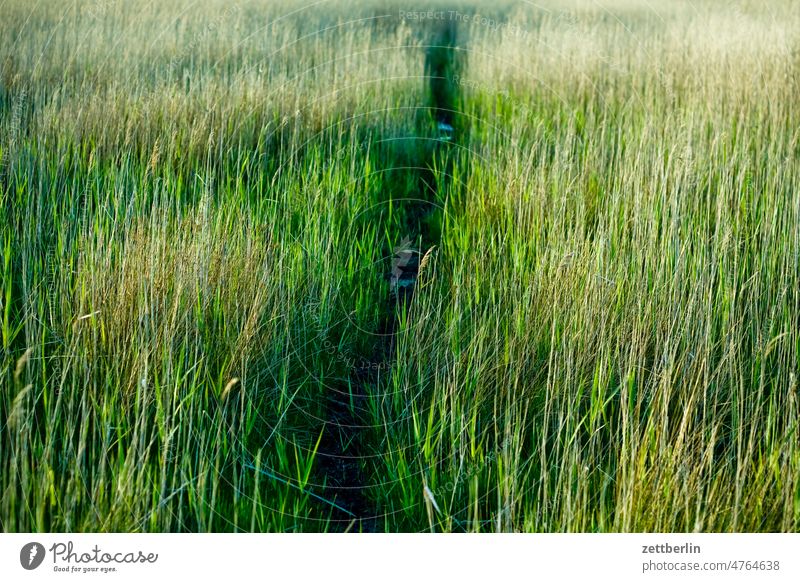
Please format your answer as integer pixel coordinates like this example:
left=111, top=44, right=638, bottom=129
left=317, top=21, right=459, bottom=532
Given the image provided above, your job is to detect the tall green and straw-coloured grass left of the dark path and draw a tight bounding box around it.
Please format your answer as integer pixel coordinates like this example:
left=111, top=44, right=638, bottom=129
left=0, top=2, right=424, bottom=531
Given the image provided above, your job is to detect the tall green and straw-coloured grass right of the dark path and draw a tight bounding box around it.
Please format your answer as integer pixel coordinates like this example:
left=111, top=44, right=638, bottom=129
left=378, top=3, right=800, bottom=531
